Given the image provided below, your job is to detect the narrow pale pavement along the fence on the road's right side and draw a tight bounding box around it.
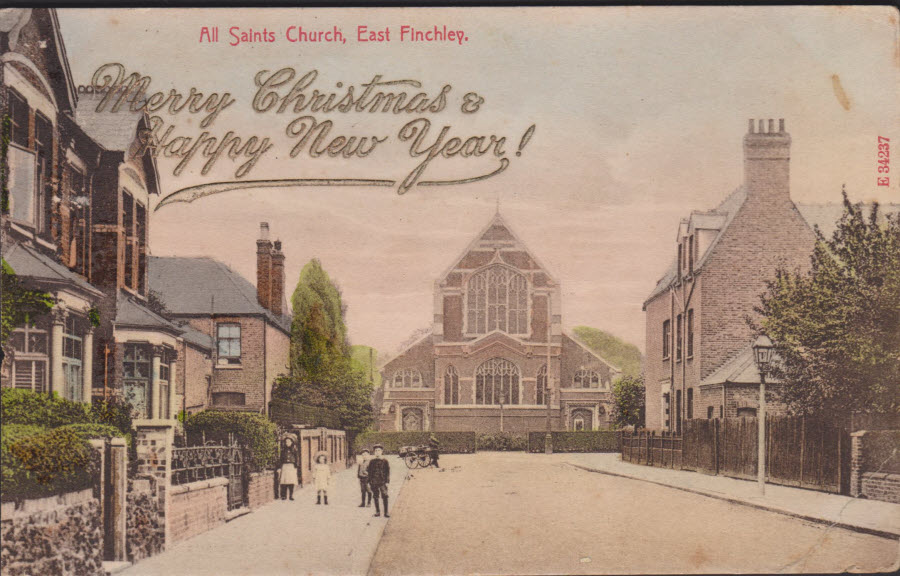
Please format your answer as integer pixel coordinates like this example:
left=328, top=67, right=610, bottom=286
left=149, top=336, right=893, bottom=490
left=567, top=454, right=900, bottom=538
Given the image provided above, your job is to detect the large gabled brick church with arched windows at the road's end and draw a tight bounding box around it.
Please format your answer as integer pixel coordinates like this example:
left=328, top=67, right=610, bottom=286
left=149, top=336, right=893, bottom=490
left=376, top=213, right=620, bottom=433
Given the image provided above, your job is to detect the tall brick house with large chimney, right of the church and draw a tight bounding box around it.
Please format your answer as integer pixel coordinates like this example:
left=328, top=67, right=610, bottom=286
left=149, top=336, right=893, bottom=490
left=643, top=120, right=896, bottom=432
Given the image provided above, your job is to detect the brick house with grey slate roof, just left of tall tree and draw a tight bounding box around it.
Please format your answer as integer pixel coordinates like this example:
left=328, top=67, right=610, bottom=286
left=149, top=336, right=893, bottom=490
left=149, top=223, right=291, bottom=414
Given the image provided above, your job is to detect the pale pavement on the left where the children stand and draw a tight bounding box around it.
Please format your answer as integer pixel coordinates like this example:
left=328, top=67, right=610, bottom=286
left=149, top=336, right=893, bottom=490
left=119, top=456, right=407, bottom=576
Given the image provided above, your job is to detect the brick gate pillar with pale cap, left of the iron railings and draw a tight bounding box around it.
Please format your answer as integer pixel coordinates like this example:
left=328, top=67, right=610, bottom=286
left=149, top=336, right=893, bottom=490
left=134, top=420, right=175, bottom=549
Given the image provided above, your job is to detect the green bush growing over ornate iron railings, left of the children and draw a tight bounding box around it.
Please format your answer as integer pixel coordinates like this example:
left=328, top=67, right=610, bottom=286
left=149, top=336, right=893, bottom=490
left=184, top=410, right=278, bottom=470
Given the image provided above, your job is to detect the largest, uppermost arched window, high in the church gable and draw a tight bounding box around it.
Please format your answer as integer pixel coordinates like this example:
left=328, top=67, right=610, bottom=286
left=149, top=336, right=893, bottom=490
left=466, top=265, right=528, bottom=334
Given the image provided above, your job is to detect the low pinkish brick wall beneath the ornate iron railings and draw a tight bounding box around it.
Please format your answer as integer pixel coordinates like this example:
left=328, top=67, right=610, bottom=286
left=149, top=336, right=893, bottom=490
left=167, top=478, right=228, bottom=545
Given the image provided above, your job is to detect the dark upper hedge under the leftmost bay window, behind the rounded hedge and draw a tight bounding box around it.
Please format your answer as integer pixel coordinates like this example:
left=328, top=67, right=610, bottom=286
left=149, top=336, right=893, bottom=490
left=0, top=388, right=91, bottom=428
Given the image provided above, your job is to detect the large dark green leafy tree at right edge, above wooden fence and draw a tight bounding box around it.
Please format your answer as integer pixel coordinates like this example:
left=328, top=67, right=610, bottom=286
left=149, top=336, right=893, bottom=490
left=756, top=193, right=900, bottom=418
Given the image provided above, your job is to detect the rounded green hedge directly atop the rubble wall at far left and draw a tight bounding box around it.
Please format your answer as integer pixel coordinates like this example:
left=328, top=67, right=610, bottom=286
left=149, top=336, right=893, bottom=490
left=3, top=426, right=97, bottom=500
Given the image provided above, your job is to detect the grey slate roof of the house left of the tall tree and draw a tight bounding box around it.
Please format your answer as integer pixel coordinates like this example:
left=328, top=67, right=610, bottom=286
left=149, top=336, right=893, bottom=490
left=149, top=256, right=291, bottom=333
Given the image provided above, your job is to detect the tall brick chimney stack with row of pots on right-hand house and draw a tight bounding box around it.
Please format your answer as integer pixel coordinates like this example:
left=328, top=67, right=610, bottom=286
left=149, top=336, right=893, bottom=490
left=744, top=118, right=791, bottom=203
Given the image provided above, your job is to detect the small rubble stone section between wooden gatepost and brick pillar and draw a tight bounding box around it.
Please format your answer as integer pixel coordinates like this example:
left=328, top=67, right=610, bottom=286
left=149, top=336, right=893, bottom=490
left=125, top=476, right=166, bottom=562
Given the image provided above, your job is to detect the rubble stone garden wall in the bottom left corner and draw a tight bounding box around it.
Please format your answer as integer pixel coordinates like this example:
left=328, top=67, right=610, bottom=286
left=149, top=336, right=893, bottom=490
left=0, top=490, right=104, bottom=576
